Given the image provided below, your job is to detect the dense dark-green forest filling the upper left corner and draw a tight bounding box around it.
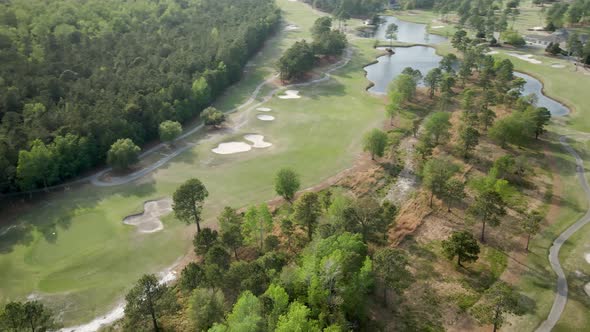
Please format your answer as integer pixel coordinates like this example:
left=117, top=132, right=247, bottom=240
left=0, top=0, right=280, bottom=192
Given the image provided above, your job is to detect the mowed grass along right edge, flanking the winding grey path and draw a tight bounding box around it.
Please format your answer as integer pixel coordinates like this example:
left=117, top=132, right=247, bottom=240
left=496, top=50, right=590, bottom=331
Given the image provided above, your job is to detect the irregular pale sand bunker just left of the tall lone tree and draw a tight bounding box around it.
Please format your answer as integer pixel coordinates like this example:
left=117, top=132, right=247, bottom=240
left=123, top=198, right=172, bottom=233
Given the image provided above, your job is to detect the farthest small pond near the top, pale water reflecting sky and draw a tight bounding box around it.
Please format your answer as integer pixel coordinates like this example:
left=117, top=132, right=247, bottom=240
left=375, top=16, right=447, bottom=44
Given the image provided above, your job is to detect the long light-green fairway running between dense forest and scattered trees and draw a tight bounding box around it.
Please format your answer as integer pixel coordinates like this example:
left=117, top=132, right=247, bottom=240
left=0, top=0, right=384, bottom=325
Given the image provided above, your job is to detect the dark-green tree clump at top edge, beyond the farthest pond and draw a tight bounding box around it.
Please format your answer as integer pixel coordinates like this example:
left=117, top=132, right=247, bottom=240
left=303, top=0, right=389, bottom=18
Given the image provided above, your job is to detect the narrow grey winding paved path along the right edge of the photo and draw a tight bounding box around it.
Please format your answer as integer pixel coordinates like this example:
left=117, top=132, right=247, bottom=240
left=536, top=136, right=590, bottom=332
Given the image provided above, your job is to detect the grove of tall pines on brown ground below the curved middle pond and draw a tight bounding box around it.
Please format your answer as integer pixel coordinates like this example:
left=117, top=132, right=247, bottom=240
left=387, top=30, right=551, bottom=242
